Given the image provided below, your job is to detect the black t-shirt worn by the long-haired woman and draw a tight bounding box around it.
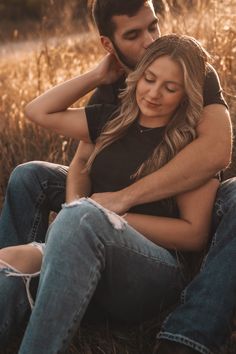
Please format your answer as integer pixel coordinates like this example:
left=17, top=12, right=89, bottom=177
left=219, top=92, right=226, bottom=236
left=86, top=105, right=178, bottom=217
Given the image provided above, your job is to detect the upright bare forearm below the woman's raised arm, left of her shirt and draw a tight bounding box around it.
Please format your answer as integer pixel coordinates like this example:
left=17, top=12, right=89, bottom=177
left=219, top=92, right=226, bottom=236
left=66, top=141, right=94, bottom=203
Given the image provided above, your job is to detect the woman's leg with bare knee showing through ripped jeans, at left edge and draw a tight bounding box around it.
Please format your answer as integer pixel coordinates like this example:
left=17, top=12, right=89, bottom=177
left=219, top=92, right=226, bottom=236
left=0, top=243, right=43, bottom=348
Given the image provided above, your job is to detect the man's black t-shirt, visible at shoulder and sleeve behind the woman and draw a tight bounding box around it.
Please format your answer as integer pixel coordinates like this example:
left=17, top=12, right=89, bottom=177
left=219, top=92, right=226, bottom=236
left=88, top=66, right=228, bottom=108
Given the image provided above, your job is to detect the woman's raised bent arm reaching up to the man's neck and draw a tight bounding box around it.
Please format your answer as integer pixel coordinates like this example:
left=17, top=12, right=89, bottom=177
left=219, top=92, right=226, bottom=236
left=25, top=54, right=121, bottom=141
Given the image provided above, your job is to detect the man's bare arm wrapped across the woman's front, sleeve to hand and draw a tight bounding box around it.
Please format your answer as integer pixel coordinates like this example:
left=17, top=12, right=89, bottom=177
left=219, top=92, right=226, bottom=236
left=92, top=104, right=232, bottom=214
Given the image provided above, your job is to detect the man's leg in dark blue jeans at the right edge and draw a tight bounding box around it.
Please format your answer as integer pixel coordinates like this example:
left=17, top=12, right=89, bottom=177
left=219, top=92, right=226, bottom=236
left=157, top=178, right=236, bottom=354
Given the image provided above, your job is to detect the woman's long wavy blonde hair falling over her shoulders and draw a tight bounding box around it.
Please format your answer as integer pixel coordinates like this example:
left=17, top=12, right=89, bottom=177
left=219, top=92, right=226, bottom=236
left=87, top=34, right=208, bottom=185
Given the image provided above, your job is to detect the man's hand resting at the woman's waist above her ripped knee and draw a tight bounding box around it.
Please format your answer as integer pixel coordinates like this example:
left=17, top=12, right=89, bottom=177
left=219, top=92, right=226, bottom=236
left=90, top=190, right=130, bottom=215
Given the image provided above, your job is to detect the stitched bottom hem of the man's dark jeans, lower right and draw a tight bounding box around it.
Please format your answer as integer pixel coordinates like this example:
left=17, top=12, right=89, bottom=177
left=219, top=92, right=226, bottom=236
left=157, top=331, right=213, bottom=354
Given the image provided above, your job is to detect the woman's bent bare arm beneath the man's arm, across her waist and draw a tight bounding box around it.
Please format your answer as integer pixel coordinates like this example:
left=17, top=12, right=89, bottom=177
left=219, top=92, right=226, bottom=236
left=125, top=179, right=219, bottom=251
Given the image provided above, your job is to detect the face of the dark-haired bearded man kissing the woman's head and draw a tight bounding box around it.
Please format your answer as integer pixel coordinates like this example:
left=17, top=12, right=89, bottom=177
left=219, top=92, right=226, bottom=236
left=112, top=0, right=160, bottom=69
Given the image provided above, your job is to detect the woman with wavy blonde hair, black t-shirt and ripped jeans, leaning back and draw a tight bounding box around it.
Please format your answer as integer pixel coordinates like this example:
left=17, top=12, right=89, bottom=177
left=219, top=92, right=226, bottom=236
left=0, top=35, right=218, bottom=354
